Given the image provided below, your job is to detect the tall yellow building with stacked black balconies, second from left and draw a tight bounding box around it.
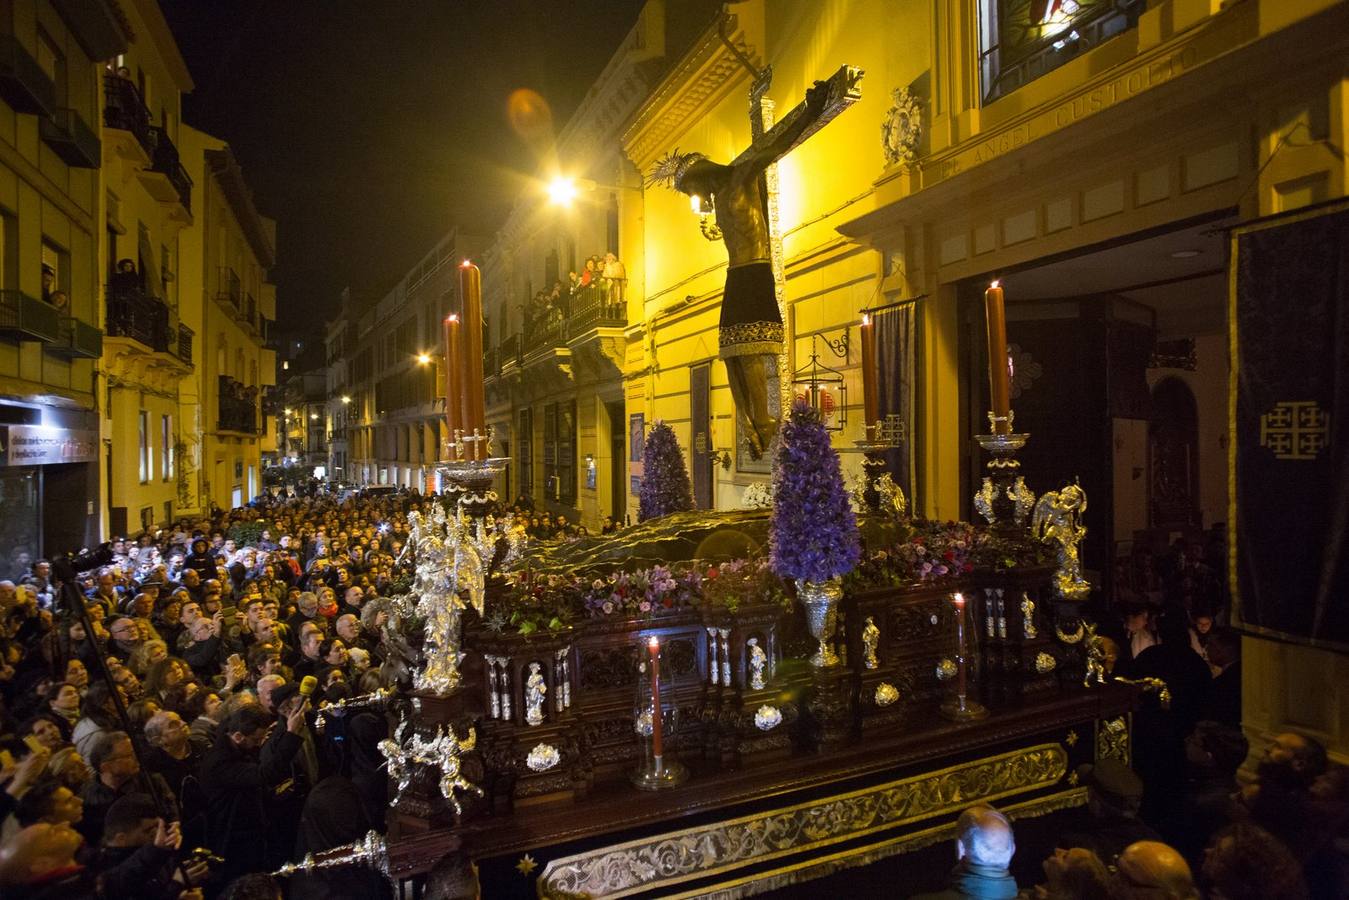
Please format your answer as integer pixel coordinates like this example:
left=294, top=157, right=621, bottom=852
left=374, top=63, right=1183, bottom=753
left=100, top=0, right=201, bottom=534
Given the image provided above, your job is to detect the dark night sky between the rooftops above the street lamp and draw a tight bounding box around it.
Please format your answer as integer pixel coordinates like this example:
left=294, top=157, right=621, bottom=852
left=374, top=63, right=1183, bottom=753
left=161, top=0, right=642, bottom=337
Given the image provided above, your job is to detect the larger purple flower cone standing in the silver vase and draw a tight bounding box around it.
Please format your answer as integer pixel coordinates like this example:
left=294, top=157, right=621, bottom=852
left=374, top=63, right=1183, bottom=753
left=772, top=401, right=861, bottom=582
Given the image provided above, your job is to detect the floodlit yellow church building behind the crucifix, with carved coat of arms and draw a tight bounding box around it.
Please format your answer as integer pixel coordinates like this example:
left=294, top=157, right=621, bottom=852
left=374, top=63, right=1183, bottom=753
left=623, top=0, right=1349, bottom=753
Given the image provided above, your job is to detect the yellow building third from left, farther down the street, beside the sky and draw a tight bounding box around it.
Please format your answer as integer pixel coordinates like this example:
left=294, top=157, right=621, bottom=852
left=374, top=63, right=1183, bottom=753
left=178, top=125, right=277, bottom=513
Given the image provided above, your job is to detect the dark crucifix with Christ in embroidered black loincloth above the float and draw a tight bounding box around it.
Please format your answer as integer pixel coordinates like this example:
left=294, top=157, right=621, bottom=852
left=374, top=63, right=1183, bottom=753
left=648, top=66, right=862, bottom=459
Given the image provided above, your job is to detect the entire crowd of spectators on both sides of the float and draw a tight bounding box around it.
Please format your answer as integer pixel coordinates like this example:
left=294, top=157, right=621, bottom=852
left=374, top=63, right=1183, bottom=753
left=0, top=491, right=1349, bottom=900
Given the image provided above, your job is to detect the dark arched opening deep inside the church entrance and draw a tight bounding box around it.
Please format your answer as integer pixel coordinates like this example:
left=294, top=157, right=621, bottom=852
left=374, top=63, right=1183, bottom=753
left=1148, top=378, right=1201, bottom=529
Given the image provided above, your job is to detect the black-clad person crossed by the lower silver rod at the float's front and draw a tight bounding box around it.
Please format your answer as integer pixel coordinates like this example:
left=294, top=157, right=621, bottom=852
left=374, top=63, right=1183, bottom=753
left=290, top=776, right=390, bottom=900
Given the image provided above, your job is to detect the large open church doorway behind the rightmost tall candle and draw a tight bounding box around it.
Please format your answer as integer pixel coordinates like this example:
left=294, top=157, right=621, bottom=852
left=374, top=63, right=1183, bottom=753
left=959, top=212, right=1232, bottom=600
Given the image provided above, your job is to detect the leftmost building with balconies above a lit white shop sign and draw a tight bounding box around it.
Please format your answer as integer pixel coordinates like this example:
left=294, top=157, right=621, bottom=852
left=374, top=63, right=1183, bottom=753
left=0, top=0, right=130, bottom=566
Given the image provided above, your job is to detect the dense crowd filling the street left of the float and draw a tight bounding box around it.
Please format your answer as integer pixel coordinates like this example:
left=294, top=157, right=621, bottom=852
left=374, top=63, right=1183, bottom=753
left=0, top=493, right=433, bottom=900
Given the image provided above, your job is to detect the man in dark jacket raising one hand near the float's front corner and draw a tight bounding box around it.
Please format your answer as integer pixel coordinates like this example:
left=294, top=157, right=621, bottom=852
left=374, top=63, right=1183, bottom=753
left=201, top=704, right=305, bottom=881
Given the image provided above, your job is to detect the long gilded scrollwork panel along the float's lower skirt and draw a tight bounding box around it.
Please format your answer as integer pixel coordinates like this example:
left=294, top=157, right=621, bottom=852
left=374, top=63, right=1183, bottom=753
left=537, top=743, right=1068, bottom=897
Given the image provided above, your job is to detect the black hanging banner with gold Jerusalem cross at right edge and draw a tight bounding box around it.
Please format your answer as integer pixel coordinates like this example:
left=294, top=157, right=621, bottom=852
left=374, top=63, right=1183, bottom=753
left=1229, top=204, right=1349, bottom=645
